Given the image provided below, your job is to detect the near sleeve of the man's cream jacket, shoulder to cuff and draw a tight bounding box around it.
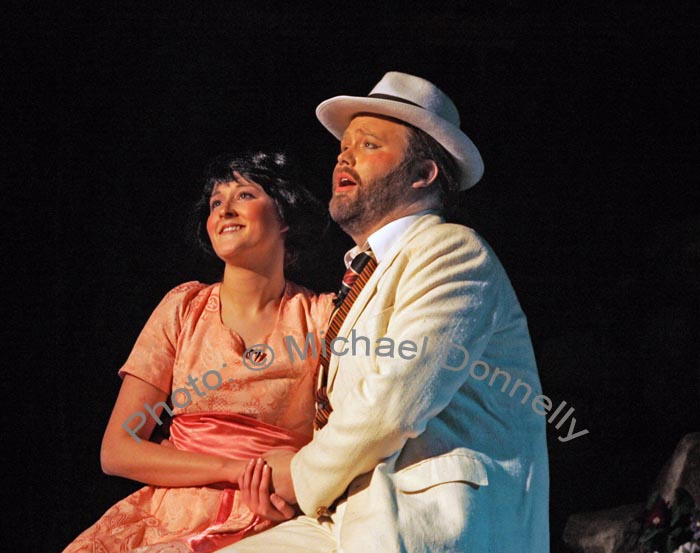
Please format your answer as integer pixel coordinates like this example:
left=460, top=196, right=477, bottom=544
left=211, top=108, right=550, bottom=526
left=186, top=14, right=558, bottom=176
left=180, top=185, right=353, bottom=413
left=292, top=225, right=505, bottom=516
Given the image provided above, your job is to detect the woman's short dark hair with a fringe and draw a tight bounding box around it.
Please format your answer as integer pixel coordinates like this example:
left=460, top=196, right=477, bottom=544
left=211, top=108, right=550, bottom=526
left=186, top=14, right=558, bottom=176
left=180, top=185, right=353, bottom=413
left=193, top=152, right=329, bottom=269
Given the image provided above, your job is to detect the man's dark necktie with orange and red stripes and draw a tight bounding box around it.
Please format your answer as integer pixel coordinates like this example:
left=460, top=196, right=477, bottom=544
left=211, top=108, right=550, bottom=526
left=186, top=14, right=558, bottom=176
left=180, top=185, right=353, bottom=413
left=314, top=250, right=377, bottom=430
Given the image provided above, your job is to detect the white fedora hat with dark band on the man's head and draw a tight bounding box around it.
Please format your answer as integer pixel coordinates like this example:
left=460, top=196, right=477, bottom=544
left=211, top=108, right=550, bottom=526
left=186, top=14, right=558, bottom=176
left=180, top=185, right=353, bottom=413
left=316, top=71, right=484, bottom=190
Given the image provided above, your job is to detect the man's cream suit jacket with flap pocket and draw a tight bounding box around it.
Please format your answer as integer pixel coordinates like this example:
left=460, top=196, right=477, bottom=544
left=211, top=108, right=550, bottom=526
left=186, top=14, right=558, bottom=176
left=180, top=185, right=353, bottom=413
left=291, top=214, right=549, bottom=553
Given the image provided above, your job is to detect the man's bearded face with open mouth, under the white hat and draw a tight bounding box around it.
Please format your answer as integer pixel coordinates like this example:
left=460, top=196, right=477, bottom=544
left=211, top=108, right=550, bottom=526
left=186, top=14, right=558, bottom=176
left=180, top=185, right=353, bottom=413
left=329, top=115, right=412, bottom=238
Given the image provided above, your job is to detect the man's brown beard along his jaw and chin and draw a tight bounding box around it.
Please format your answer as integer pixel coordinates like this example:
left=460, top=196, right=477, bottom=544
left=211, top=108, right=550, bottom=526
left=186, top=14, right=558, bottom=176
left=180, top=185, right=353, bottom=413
left=328, top=156, right=412, bottom=236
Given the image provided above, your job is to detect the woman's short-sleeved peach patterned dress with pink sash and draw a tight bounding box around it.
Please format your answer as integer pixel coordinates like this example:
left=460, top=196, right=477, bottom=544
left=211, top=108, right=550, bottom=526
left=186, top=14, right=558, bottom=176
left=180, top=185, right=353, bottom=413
left=64, top=282, right=333, bottom=553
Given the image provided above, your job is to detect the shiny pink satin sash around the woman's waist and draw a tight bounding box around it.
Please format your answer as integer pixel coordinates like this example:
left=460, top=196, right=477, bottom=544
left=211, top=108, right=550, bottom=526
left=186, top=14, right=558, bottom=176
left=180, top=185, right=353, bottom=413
left=170, top=413, right=311, bottom=460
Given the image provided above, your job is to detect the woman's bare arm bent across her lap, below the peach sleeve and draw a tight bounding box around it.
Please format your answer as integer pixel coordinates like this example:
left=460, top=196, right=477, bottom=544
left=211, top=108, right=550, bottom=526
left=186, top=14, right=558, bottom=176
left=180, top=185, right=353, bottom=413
left=100, top=374, right=246, bottom=487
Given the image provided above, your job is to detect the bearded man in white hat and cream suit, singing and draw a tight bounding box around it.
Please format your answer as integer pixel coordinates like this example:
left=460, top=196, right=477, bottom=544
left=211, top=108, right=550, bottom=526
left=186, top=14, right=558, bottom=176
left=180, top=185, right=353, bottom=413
left=225, top=72, right=549, bottom=553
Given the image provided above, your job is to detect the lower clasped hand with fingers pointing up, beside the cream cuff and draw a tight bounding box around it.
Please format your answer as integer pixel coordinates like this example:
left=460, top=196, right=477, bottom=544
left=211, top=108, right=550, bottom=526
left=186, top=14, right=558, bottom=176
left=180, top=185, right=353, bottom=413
left=238, top=458, right=297, bottom=531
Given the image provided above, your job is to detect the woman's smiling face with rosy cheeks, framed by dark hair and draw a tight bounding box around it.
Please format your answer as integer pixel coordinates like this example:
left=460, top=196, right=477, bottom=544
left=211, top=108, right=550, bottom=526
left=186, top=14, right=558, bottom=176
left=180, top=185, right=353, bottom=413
left=207, top=173, right=287, bottom=265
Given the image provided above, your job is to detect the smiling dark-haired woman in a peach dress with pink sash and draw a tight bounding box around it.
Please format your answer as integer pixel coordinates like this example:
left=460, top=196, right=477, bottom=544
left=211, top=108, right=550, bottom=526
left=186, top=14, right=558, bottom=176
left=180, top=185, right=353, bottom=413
left=64, top=153, right=332, bottom=553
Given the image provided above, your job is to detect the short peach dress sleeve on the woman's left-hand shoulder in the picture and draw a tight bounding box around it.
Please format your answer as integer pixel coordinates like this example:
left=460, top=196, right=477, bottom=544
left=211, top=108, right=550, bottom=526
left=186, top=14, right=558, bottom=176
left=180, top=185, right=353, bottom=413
left=119, top=281, right=206, bottom=395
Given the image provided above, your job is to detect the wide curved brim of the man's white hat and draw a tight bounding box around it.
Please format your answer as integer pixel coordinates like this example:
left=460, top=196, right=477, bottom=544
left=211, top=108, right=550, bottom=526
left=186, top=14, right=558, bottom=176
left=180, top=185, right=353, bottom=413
left=316, top=96, right=484, bottom=190
